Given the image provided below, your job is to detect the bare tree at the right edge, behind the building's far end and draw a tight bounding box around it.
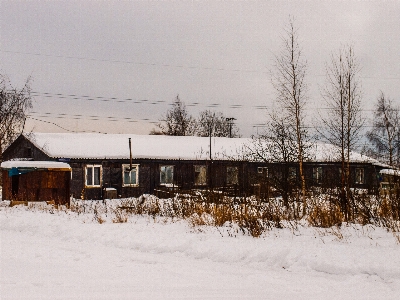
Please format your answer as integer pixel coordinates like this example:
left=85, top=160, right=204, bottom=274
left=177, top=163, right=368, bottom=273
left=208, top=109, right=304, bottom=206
left=367, top=91, right=400, bottom=166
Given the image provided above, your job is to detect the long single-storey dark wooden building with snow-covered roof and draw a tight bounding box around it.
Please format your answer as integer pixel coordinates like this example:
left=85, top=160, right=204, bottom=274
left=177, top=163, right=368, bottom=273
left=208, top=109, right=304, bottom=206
left=3, top=133, right=387, bottom=199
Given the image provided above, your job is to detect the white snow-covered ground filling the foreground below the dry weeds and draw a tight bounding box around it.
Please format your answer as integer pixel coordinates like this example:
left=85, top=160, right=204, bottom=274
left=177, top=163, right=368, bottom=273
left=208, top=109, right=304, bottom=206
left=0, top=201, right=400, bottom=300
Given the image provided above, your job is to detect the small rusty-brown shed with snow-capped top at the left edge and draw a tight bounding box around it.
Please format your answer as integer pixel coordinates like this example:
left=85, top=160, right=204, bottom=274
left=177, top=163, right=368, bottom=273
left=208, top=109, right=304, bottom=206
left=1, top=160, right=71, bottom=205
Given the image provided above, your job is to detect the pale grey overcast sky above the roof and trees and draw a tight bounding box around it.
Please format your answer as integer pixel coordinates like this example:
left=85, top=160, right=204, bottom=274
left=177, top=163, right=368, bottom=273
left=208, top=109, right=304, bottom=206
left=0, top=0, right=400, bottom=137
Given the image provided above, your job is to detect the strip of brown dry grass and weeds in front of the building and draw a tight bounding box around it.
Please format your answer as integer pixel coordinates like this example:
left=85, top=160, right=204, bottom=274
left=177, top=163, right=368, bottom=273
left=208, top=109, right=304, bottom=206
left=9, top=191, right=400, bottom=239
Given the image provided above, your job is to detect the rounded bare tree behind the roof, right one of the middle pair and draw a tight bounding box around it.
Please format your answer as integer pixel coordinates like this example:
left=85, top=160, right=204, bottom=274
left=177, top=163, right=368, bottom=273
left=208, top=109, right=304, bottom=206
left=196, top=110, right=239, bottom=137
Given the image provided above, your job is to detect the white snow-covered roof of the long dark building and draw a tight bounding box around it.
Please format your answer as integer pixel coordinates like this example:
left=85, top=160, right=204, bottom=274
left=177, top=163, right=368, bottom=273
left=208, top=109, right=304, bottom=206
left=24, top=133, right=383, bottom=166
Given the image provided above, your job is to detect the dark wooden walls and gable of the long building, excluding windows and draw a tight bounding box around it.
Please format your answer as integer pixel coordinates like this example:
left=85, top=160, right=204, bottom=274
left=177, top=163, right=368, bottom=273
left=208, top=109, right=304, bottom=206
left=3, top=136, right=382, bottom=199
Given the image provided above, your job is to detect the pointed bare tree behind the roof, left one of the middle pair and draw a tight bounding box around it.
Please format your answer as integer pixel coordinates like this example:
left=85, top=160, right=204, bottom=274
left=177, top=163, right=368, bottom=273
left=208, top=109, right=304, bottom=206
left=158, top=95, right=194, bottom=136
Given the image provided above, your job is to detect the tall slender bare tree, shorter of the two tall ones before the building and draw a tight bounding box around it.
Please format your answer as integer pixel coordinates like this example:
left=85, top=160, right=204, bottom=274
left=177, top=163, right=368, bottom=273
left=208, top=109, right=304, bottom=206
left=319, top=46, right=364, bottom=217
